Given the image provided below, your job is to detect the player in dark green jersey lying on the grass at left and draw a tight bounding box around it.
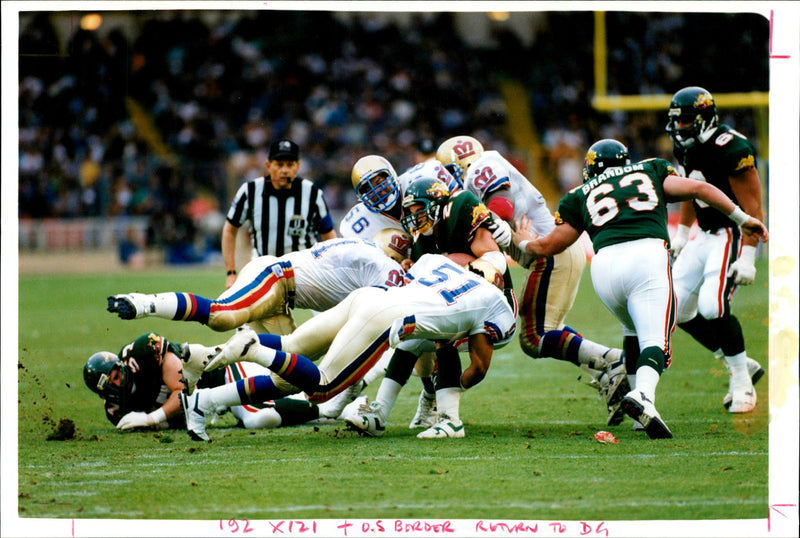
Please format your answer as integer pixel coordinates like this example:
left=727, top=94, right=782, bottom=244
left=83, top=332, right=320, bottom=431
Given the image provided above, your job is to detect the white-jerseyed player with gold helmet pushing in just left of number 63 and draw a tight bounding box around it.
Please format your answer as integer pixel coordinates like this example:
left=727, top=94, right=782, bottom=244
left=436, top=136, right=629, bottom=424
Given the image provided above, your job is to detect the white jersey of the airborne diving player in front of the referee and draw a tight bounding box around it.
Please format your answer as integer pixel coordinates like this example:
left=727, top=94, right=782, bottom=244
left=283, top=238, right=404, bottom=311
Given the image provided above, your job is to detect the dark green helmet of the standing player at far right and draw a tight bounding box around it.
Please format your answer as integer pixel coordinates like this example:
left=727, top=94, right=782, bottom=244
left=666, top=86, right=719, bottom=149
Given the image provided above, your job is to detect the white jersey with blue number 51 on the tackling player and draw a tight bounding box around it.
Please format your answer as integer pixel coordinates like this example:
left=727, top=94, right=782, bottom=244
left=386, top=254, right=516, bottom=347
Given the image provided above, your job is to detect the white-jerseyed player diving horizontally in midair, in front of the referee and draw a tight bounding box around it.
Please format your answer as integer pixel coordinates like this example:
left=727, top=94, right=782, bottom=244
left=108, top=233, right=410, bottom=362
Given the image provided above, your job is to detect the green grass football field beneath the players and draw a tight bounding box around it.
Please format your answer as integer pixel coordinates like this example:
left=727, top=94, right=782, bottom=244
left=10, top=260, right=768, bottom=535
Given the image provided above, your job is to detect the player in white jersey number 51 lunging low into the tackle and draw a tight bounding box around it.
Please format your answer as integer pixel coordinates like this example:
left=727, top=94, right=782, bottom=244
left=181, top=254, right=516, bottom=440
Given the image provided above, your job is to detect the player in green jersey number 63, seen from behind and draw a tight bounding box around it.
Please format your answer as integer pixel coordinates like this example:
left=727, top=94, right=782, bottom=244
left=512, top=139, right=768, bottom=439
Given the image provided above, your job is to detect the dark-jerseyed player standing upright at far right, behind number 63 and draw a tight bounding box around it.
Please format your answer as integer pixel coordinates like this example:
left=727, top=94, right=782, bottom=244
left=667, top=86, right=764, bottom=413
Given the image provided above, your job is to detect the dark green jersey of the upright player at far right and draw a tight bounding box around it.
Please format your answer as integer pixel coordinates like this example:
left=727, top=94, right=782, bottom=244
left=674, top=125, right=756, bottom=231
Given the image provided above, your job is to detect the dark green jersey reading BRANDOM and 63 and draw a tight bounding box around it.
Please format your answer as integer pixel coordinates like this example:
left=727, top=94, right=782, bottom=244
left=556, top=159, right=676, bottom=252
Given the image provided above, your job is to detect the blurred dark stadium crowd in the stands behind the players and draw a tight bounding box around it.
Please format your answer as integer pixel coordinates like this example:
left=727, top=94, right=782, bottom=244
left=19, top=11, right=768, bottom=253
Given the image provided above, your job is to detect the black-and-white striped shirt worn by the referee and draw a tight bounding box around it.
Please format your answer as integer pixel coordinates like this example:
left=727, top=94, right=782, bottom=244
left=227, top=176, right=333, bottom=256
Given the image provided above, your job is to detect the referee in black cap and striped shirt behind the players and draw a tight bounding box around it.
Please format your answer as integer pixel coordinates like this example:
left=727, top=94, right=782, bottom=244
left=222, top=139, right=336, bottom=289
